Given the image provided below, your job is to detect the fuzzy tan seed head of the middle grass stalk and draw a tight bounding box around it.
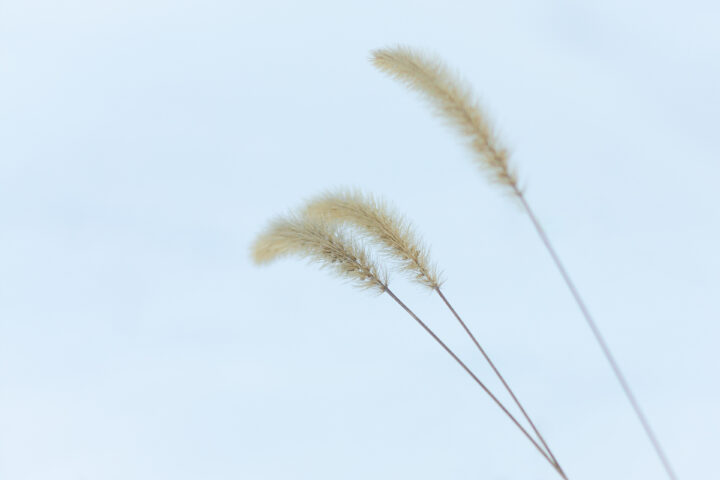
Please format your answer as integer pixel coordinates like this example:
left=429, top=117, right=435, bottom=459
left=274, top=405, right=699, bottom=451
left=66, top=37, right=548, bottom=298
left=305, top=190, right=441, bottom=289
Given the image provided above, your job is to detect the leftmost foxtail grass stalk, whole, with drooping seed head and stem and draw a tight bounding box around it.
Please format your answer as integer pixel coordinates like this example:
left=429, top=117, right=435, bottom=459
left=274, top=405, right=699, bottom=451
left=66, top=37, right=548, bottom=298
left=252, top=216, right=567, bottom=479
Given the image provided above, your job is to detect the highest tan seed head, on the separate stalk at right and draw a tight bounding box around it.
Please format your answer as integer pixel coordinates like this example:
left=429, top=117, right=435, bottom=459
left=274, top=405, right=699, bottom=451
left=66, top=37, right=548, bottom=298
left=372, top=46, right=520, bottom=195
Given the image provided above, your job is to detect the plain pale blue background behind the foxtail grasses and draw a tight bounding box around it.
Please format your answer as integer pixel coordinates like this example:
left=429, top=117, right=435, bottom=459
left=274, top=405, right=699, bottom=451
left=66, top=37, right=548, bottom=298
left=0, top=0, right=720, bottom=480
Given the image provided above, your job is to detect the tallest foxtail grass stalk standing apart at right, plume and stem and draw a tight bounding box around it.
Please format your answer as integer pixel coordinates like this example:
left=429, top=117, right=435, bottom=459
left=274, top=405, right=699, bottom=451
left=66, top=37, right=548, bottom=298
left=372, top=47, right=677, bottom=480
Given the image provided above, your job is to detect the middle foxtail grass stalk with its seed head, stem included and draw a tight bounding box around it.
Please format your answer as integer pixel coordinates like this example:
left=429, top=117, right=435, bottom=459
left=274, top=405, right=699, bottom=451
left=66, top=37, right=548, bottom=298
left=304, top=189, right=567, bottom=478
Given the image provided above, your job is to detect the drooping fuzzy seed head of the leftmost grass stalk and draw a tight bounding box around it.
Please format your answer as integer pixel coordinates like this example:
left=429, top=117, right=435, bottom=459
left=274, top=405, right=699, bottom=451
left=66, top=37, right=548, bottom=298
left=252, top=216, right=388, bottom=293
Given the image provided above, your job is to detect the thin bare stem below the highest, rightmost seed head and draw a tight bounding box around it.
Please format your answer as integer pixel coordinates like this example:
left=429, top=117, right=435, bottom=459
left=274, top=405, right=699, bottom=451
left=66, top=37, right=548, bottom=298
left=515, top=189, right=677, bottom=480
